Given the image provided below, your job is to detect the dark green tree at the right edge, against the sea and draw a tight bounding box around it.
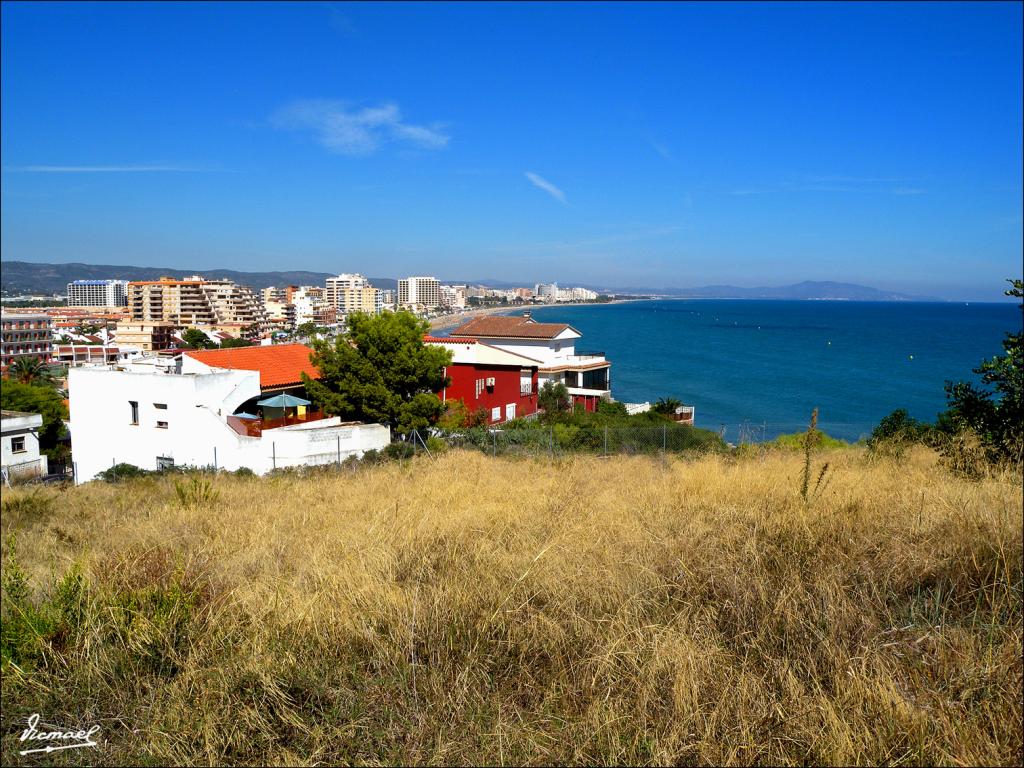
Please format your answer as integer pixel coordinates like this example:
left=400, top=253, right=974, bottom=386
left=946, top=280, right=1024, bottom=462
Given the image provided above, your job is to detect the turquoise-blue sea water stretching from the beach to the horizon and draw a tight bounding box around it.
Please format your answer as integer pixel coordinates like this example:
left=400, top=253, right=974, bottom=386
left=516, top=299, right=1021, bottom=441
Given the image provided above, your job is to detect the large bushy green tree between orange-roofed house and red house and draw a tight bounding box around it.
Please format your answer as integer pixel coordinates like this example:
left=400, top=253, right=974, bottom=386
left=302, top=311, right=452, bottom=433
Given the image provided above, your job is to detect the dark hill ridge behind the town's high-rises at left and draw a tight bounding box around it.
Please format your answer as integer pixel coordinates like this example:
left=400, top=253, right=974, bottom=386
left=0, top=261, right=397, bottom=296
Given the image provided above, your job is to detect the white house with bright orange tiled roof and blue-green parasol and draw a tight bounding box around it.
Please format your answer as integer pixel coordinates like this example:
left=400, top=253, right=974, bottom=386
left=69, top=344, right=390, bottom=482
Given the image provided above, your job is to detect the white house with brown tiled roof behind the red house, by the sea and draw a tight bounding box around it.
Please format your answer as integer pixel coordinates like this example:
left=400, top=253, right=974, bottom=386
left=451, top=312, right=611, bottom=411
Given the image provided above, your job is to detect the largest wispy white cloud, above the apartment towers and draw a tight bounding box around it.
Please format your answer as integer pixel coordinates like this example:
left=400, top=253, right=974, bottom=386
left=270, top=98, right=450, bottom=156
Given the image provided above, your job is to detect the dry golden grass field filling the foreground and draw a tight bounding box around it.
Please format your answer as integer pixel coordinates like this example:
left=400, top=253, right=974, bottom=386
left=0, top=447, right=1024, bottom=765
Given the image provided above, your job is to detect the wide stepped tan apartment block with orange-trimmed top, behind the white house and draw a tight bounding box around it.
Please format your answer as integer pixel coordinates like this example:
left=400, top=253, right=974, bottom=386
left=128, top=275, right=267, bottom=332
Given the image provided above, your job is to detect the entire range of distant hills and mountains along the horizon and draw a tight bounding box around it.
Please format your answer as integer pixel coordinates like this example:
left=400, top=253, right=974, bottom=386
left=0, top=261, right=943, bottom=301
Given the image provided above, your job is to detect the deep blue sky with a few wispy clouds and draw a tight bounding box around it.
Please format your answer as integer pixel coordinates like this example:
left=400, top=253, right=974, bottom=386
left=0, top=2, right=1024, bottom=299
